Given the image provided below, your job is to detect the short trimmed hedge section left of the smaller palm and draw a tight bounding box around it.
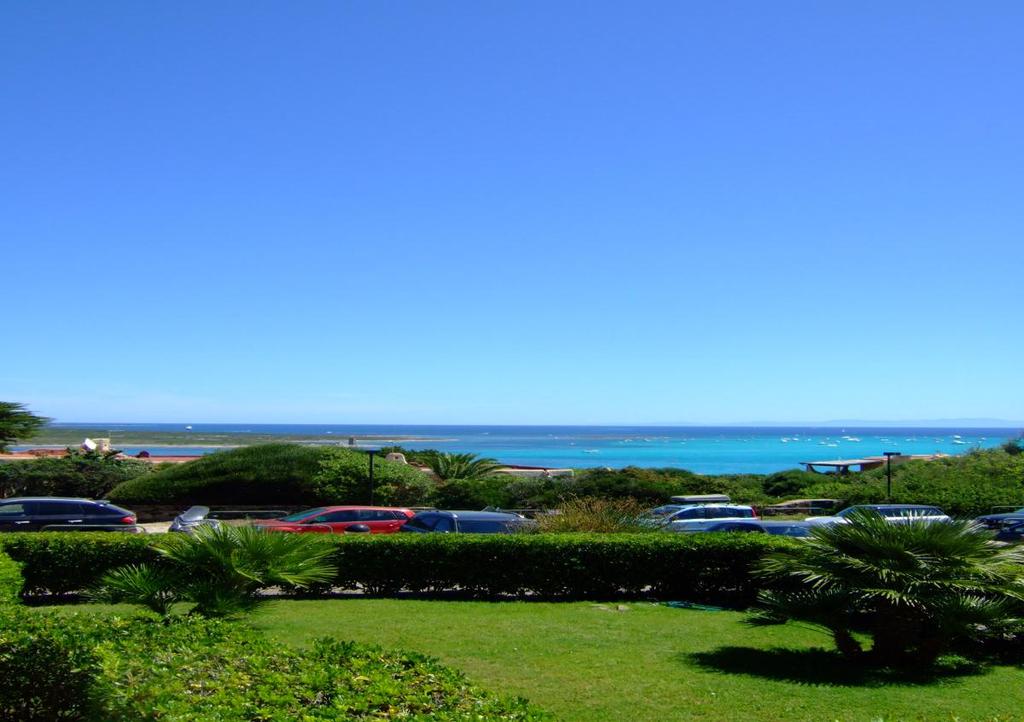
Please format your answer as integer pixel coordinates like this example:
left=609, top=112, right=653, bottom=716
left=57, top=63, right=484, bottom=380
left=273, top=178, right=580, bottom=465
left=0, top=532, right=158, bottom=594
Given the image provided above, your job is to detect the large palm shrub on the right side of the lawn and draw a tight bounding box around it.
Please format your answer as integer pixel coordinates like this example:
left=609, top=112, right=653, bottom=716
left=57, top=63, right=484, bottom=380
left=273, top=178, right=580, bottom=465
left=753, top=511, right=1024, bottom=666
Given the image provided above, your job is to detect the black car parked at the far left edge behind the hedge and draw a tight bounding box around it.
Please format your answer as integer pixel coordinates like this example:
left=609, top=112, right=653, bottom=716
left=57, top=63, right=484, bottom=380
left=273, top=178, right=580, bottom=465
left=0, top=497, right=138, bottom=532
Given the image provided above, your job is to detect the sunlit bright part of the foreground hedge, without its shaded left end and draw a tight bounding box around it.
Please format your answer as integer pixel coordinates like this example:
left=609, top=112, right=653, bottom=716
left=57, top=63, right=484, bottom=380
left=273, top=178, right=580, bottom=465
left=96, top=622, right=545, bottom=722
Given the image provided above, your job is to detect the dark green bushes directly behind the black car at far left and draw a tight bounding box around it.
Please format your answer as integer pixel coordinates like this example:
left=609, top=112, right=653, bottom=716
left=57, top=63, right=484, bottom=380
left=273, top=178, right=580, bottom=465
left=0, top=451, right=153, bottom=499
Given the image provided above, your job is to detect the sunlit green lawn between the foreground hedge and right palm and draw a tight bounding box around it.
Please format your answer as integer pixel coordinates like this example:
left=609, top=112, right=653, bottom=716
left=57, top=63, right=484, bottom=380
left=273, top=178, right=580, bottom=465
left=243, top=599, right=1024, bottom=722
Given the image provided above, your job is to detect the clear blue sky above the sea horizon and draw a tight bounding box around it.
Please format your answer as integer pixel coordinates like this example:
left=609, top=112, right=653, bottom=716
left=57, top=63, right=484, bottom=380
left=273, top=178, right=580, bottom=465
left=0, top=0, right=1024, bottom=423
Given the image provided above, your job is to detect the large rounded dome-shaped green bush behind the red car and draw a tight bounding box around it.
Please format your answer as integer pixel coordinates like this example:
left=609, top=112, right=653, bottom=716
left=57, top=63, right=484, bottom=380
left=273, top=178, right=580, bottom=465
left=110, top=443, right=433, bottom=506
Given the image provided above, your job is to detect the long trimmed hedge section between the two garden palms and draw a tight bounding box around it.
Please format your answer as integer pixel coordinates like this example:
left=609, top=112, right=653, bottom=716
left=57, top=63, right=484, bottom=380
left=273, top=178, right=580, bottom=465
left=334, top=534, right=793, bottom=606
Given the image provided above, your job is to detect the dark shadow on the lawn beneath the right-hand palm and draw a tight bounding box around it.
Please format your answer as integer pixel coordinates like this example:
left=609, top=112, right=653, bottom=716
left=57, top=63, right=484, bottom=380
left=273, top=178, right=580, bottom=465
left=680, top=647, right=985, bottom=687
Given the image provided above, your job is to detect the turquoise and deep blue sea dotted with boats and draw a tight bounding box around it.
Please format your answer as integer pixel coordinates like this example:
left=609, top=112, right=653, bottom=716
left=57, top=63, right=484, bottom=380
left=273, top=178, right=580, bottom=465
left=22, top=424, right=1020, bottom=473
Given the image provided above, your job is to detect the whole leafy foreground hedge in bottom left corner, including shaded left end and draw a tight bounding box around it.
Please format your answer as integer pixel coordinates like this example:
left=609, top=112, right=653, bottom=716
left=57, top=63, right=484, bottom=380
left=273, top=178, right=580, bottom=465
left=0, top=607, right=546, bottom=722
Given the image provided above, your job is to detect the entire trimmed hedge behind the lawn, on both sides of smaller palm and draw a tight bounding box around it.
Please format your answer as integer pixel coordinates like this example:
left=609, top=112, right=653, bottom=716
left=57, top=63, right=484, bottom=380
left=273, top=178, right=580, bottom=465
left=0, top=533, right=795, bottom=606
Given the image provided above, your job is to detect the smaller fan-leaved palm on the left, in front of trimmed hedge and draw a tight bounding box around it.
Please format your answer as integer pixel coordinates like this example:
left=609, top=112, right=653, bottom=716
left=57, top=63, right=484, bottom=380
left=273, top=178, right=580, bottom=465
left=93, top=525, right=336, bottom=618
